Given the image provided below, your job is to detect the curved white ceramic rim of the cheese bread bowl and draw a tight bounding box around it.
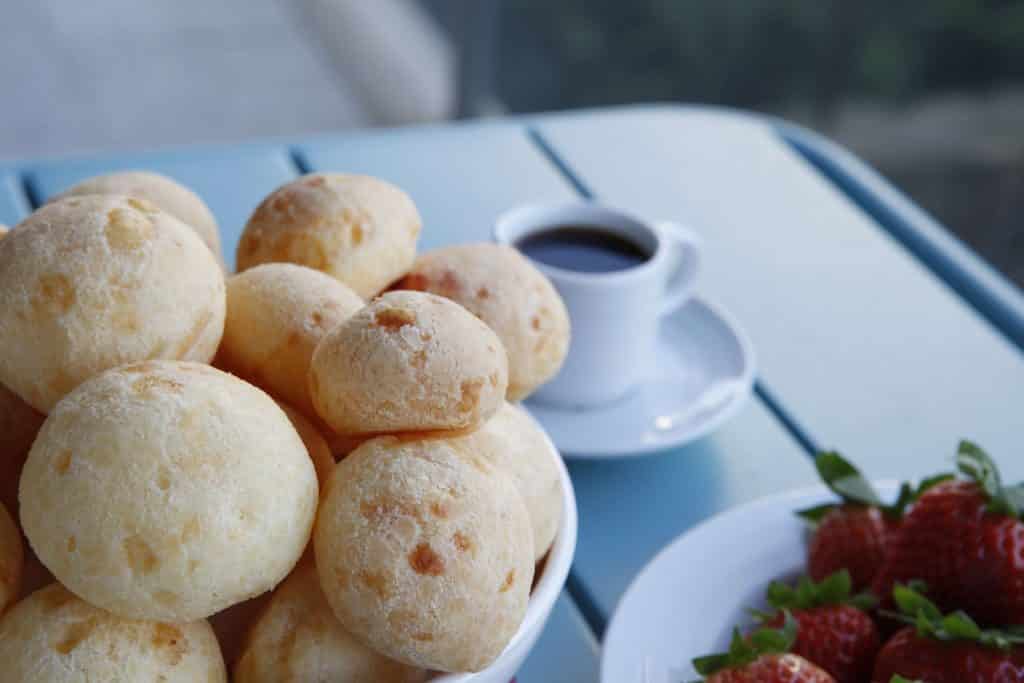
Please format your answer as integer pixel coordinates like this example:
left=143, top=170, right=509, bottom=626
left=429, top=415, right=579, bottom=683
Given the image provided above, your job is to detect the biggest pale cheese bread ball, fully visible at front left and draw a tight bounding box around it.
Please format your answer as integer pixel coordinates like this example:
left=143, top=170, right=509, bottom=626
left=19, top=360, right=317, bottom=622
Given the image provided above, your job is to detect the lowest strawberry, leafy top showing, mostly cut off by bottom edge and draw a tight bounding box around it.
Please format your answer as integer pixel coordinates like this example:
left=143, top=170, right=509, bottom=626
left=693, top=612, right=836, bottom=683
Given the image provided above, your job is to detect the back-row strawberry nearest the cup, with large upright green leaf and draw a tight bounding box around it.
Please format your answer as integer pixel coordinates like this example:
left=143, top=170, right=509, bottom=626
left=797, top=452, right=951, bottom=591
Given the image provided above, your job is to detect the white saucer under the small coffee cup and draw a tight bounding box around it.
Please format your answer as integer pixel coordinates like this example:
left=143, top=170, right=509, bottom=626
left=526, top=297, right=755, bottom=458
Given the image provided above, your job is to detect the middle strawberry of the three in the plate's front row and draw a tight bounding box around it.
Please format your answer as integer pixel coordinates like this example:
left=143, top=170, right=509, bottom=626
left=755, top=569, right=882, bottom=683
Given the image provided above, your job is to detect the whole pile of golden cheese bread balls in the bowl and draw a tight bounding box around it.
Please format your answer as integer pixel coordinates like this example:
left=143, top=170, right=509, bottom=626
left=0, top=171, right=569, bottom=683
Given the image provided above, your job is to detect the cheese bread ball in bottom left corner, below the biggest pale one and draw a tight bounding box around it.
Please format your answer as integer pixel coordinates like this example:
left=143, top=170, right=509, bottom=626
left=0, top=584, right=227, bottom=683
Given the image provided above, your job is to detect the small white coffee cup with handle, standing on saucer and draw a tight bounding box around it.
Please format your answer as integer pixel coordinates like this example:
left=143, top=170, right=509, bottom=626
left=495, top=202, right=700, bottom=409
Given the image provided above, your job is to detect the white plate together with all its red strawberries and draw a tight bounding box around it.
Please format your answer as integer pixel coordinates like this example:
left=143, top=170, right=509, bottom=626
left=601, top=441, right=1024, bottom=683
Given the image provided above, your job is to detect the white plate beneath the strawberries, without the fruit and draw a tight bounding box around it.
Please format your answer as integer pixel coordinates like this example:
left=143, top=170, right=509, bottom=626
left=601, top=482, right=897, bottom=683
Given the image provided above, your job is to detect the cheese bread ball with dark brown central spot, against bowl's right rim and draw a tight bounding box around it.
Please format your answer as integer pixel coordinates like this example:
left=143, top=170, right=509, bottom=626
left=313, top=436, right=534, bottom=672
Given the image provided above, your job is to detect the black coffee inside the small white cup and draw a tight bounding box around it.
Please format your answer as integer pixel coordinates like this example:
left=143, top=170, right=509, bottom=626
left=516, top=225, right=650, bottom=272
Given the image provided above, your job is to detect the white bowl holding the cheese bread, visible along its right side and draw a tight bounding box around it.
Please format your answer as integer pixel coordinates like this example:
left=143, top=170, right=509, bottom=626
left=430, top=413, right=578, bottom=683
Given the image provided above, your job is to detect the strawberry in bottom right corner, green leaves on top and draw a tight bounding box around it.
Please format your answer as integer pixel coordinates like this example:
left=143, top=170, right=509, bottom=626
left=871, top=585, right=1024, bottom=683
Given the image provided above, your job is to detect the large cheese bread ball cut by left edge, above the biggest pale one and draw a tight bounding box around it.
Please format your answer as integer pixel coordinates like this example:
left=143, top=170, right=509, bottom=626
left=0, top=195, right=224, bottom=413
